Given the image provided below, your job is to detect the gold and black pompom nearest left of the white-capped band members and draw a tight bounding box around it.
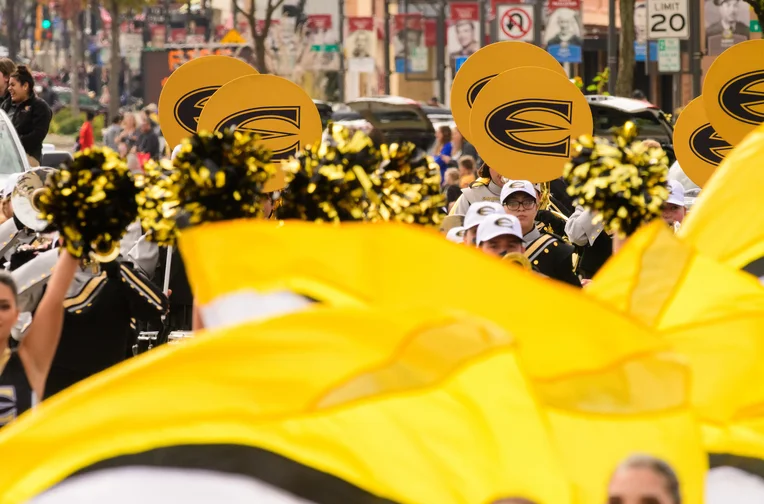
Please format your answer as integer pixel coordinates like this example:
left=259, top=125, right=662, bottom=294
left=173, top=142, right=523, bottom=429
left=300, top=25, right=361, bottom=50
left=369, top=142, right=446, bottom=226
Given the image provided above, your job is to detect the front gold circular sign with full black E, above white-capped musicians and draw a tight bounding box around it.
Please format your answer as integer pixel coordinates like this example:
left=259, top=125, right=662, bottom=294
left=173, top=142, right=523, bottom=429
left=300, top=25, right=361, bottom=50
left=470, top=67, right=593, bottom=182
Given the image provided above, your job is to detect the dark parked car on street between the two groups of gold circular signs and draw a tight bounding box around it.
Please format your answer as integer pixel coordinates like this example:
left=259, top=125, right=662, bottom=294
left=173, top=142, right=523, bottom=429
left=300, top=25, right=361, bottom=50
left=332, top=96, right=435, bottom=150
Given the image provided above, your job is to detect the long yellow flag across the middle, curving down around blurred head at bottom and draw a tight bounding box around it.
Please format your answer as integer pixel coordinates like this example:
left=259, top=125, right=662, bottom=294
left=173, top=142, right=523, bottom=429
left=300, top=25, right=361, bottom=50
left=181, top=221, right=705, bottom=503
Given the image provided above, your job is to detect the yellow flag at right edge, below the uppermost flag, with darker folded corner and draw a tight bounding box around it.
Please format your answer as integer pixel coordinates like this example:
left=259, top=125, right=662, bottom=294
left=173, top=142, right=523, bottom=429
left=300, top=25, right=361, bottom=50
left=586, top=223, right=764, bottom=458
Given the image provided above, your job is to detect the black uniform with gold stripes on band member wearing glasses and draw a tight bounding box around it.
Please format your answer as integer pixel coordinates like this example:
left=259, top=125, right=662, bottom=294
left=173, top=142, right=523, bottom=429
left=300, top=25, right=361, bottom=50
left=523, top=227, right=581, bottom=287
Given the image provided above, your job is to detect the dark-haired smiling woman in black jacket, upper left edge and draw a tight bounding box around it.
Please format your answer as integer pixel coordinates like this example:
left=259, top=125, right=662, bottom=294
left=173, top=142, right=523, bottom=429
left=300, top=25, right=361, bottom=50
left=2, top=65, right=53, bottom=166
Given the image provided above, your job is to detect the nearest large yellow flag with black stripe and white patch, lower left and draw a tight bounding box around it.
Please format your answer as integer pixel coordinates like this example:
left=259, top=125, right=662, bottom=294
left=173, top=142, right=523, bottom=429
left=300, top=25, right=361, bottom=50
left=0, top=308, right=573, bottom=504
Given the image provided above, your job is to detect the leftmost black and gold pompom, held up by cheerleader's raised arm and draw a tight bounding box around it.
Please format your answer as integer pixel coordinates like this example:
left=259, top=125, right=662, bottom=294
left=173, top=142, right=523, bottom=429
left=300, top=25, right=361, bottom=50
left=37, top=147, right=138, bottom=262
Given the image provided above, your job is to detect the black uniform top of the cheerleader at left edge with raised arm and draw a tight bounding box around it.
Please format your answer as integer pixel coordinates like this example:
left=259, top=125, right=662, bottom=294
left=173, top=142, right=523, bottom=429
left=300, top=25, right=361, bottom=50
left=0, top=348, right=37, bottom=427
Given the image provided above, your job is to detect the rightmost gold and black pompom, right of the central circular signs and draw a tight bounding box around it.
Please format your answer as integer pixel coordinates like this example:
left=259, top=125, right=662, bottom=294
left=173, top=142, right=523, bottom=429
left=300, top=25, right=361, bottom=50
left=564, top=122, right=669, bottom=237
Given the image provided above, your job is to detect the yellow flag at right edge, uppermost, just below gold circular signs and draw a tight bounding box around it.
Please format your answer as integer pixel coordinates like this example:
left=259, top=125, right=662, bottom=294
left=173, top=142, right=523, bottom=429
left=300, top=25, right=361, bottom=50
left=679, top=126, right=764, bottom=277
